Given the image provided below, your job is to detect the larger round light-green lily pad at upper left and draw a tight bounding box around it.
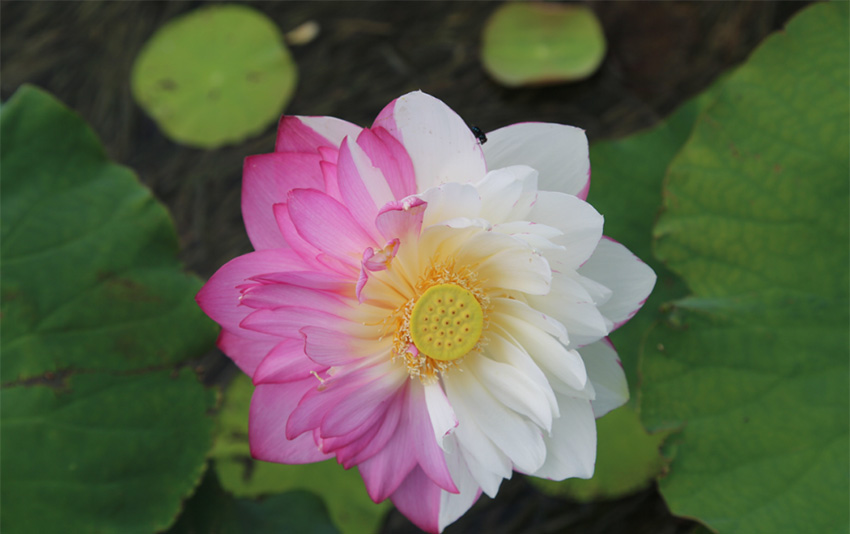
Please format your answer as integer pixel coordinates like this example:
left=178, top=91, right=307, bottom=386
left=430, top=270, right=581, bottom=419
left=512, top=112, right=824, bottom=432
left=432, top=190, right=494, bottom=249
left=132, top=5, right=297, bottom=148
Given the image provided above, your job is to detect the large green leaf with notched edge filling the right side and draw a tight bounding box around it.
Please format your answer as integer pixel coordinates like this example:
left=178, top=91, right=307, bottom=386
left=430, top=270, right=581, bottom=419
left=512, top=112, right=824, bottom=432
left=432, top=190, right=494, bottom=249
left=641, top=2, right=850, bottom=533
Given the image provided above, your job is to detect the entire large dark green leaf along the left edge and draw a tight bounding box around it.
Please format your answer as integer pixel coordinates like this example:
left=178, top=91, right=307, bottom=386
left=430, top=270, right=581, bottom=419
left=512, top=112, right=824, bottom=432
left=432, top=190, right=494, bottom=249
left=0, top=87, right=215, bottom=533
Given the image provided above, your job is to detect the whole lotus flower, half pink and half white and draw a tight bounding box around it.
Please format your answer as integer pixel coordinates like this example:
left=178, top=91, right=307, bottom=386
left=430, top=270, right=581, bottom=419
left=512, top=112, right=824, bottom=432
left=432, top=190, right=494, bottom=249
left=197, top=92, right=655, bottom=532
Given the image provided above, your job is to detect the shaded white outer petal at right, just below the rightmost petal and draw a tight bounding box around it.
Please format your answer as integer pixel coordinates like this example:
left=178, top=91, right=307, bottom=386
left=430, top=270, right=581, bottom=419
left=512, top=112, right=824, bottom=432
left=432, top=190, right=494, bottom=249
left=578, top=339, right=629, bottom=418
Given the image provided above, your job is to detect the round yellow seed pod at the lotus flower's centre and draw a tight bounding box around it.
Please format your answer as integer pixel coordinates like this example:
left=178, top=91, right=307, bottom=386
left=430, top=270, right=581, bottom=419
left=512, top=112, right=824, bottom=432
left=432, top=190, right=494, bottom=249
left=410, top=284, right=484, bottom=361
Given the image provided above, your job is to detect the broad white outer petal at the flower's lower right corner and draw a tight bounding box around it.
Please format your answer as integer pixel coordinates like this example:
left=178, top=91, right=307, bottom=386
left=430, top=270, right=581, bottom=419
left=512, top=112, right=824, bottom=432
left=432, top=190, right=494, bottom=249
left=530, top=395, right=596, bottom=480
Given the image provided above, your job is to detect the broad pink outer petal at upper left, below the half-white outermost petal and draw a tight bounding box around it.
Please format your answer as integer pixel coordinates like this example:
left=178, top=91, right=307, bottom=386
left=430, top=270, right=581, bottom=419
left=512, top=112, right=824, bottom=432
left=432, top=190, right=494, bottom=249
left=242, top=153, right=324, bottom=250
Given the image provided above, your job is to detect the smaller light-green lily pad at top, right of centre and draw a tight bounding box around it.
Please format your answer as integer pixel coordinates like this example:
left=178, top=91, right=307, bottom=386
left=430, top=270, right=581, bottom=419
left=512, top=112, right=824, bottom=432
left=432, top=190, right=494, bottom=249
left=481, top=2, right=605, bottom=87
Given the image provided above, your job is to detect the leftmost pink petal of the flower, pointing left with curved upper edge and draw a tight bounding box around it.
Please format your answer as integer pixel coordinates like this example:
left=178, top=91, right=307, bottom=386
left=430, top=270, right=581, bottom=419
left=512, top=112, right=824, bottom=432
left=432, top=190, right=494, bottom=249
left=195, top=249, right=305, bottom=339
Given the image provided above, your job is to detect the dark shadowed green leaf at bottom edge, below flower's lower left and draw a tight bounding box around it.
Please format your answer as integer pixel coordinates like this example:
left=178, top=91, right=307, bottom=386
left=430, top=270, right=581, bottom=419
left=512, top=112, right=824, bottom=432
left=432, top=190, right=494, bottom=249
left=168, top=470, right=339, bottom=534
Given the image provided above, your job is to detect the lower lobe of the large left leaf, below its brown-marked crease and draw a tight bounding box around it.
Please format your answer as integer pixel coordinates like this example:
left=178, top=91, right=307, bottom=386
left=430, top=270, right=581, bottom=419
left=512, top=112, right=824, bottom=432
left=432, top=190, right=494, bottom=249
left=0, top=372, right=212, bottom=533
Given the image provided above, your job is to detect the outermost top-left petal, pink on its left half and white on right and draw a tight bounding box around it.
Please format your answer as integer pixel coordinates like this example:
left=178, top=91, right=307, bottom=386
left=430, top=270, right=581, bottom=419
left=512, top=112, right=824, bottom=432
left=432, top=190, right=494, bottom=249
left=275, top=115, right=361, bottom=152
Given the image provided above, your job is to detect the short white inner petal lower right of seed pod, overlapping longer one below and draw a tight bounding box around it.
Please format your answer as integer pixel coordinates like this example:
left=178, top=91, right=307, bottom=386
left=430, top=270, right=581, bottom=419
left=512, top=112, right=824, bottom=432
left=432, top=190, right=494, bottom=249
left=464, top=356, right=552, bottom=432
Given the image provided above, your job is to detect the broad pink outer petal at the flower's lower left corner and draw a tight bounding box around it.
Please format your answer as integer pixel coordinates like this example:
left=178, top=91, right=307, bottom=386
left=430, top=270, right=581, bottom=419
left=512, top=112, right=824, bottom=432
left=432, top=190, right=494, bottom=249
left=248, top=377, right=330, bottom=464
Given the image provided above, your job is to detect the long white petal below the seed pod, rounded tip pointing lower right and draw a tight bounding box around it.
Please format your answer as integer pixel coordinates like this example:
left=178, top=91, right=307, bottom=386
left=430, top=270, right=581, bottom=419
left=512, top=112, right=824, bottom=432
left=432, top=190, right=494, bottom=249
left=443, top=371, right=546, bottom=478
